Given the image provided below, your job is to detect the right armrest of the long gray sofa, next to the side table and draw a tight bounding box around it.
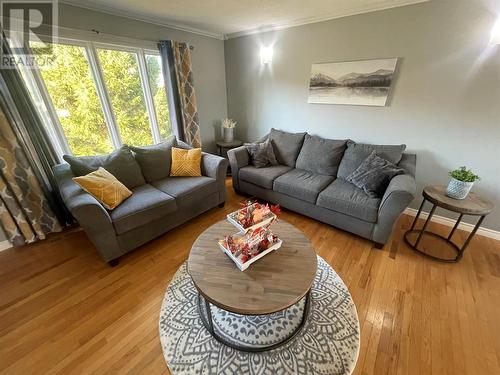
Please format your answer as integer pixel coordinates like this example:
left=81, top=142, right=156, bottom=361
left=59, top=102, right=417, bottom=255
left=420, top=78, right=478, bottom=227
left=372, top=174, right=417, bottom=244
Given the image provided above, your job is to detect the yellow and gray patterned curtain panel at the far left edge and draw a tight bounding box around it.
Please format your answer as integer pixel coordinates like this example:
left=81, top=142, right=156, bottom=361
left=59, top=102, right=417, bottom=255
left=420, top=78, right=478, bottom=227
left=0, top=108, right=62, bottom=246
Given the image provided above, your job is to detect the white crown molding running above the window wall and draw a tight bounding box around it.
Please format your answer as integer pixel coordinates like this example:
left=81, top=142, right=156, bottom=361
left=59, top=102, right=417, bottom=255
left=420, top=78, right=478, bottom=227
left=59, top=0, right=225, bottom=40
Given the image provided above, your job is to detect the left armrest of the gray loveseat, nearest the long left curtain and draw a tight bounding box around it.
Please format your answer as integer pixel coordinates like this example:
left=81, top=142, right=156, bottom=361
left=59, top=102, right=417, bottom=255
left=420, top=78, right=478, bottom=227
left=53, top=164, right=122, bottom=262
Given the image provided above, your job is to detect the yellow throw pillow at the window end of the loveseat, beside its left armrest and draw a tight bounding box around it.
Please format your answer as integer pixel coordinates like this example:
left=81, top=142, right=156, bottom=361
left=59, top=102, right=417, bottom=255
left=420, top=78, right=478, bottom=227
left=73, top=167, right=132, bottom=210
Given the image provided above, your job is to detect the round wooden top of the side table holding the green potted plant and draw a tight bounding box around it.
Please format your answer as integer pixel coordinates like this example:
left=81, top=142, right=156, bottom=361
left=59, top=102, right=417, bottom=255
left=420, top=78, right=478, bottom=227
left=423, top=185, right=494, bottom=216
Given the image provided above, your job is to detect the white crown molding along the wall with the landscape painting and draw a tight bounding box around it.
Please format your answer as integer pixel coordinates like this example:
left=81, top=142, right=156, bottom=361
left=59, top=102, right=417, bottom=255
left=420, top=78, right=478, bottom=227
left=224, top=0, right=431, bottom=39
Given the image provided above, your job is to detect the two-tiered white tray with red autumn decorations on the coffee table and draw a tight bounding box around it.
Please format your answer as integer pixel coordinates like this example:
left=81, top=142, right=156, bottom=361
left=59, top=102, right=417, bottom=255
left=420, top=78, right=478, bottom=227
left=219, top=201, right=282, bottom=271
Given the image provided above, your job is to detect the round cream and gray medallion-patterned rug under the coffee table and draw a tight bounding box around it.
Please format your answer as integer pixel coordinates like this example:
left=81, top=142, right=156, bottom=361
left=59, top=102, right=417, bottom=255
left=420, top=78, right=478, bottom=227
left=159, top=256, right=360, bottom=375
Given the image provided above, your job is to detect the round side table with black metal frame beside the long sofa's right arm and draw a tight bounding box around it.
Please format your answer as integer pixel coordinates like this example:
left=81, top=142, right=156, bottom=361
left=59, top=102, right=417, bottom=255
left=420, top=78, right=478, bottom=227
left=404, top=185, right=494, bottom=263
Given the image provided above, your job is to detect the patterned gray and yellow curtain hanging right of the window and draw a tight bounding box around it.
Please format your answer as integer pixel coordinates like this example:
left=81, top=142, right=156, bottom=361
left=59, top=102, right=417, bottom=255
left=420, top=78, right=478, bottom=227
left=158, top=41, right=201, bottom=147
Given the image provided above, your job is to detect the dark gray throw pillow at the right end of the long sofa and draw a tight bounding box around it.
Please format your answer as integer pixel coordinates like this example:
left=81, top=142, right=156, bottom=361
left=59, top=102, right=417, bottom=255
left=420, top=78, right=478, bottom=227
left=346, top=151, right=404, bottom=198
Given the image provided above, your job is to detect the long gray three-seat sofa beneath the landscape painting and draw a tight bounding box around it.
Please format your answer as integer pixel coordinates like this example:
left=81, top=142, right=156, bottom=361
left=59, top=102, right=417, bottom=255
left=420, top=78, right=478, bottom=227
left=228, top=129, right=416, bottom=248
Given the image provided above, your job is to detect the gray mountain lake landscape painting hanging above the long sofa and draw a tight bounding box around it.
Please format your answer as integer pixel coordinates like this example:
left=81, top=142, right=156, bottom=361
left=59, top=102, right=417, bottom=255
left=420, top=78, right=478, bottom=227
left=308, top=58, right=398, bottom=107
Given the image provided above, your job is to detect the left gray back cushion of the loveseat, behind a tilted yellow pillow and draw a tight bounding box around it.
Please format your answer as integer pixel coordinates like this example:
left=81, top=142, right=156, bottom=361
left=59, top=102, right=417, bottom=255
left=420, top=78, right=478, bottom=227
left=63, top=145, right=146, bottom=189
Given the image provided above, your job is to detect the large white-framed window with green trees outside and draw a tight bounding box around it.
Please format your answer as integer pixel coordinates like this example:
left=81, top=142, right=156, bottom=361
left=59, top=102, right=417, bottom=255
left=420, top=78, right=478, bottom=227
left=23, top=39, right=172, bottom=156
